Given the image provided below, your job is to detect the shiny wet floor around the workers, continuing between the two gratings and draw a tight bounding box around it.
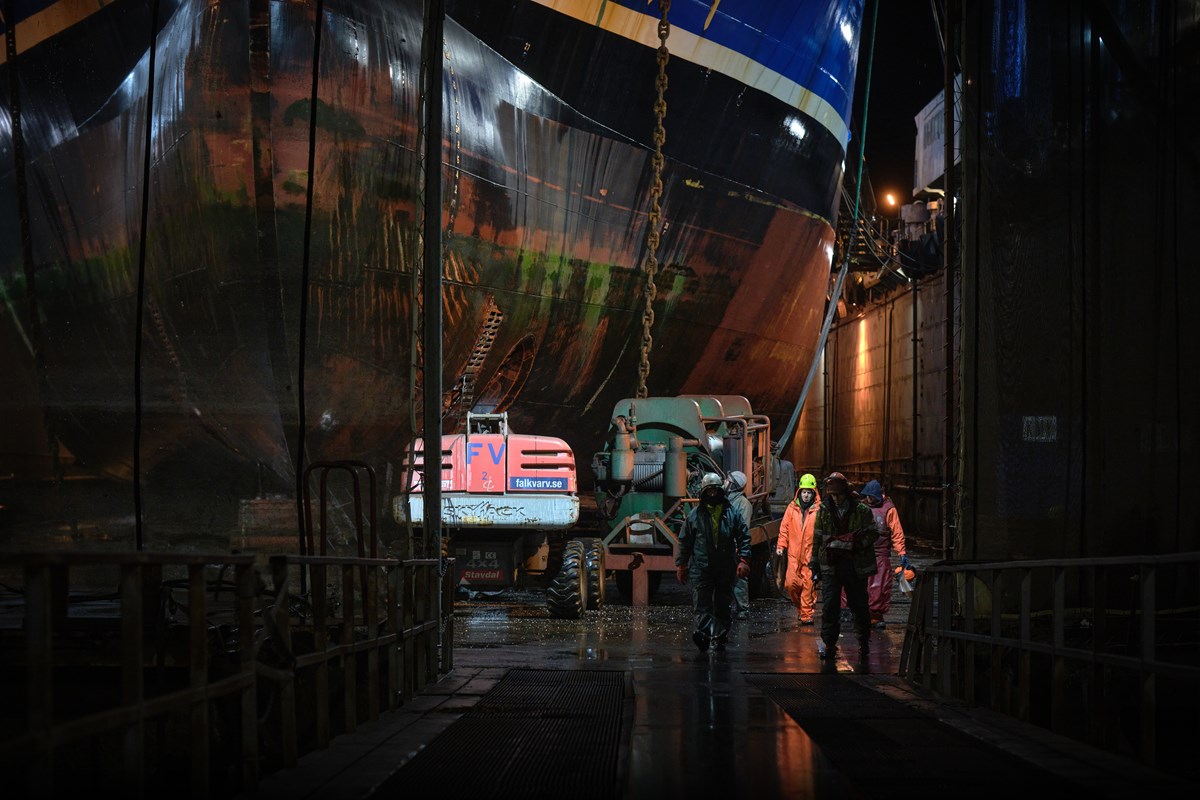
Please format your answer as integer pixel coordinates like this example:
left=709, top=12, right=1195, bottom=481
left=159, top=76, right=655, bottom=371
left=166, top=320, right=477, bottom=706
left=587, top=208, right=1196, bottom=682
left=427, top=576, right=910, bottom=800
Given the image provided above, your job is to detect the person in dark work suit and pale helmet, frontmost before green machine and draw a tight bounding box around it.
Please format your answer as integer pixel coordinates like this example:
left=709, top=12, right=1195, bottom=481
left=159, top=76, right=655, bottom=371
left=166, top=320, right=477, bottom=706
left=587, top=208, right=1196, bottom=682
left=676, top=473, right=748, bottom=652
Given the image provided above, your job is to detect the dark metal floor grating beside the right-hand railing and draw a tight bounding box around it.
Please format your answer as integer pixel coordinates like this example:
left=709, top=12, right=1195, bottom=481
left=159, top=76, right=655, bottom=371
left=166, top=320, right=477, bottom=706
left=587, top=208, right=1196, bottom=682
left=746, top=673, right=1079, bottom=800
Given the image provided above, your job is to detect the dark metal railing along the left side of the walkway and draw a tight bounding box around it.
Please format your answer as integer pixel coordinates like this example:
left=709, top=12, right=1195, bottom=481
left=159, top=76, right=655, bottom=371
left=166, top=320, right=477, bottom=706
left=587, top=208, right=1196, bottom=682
left=0, top=553, right=454, bottom=798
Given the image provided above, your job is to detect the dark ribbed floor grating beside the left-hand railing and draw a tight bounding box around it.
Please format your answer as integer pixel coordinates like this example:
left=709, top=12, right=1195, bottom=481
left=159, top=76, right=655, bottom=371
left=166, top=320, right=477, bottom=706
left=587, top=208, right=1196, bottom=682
left=376, top=669, right=625, bottom=800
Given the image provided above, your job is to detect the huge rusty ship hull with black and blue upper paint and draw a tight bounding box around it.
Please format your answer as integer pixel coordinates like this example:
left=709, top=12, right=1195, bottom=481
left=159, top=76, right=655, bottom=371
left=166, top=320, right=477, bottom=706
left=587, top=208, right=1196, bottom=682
left=0, top=0, right=862, bottom=541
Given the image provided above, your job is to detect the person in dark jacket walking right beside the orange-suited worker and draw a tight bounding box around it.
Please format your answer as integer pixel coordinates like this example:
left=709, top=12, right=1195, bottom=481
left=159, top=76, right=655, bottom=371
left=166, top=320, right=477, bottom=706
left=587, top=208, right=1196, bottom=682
left=809, top=473, right=880, bottom=658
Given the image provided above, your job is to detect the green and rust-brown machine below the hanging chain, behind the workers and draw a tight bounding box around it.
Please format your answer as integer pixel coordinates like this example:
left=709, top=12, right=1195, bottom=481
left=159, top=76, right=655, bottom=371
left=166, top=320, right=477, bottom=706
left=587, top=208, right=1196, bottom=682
left=592, top=395, right=785, bottom=606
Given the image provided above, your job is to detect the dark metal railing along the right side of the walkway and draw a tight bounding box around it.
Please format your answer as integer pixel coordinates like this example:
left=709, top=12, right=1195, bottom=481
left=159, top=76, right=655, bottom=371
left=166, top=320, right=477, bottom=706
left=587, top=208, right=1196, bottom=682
left=899, top=553, right=1200, bottom=766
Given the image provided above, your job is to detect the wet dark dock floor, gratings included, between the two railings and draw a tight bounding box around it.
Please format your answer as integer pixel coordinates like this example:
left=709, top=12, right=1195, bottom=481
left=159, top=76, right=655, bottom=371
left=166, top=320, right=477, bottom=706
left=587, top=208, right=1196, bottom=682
left=246, top=565, right=1196, bottom=800
